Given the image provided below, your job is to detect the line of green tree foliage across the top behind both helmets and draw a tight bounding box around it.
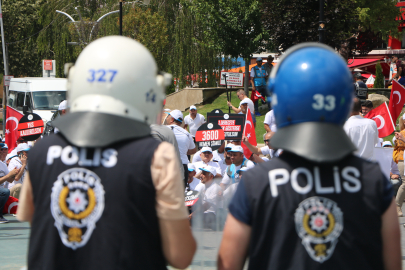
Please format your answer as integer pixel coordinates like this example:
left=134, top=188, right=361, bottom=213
left=2, top=0, right=399, bottom=88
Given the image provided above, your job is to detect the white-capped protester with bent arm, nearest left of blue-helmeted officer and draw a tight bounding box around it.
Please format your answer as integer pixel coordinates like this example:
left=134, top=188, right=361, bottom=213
left=220, top=145, right=255, bottom=190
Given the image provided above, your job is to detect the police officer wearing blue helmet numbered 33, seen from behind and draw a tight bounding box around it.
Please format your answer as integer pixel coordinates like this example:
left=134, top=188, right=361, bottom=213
left=218, top=43, right=401, bottom=270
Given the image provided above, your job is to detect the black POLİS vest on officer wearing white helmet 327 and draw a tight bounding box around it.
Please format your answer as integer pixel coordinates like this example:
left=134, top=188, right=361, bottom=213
left=28, top=134, right=166, bottom=270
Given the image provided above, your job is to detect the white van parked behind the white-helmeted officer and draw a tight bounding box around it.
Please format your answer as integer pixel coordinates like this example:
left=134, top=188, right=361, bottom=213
left=7, top=77, right=67, bottom=123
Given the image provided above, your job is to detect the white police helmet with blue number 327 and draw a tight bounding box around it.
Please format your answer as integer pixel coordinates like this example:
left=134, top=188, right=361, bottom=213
left=55, top=36, right=171, bottom=147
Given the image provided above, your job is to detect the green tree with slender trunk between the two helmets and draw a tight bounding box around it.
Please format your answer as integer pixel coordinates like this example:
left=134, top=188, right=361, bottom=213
left=190, top=0, right=271, bottom=93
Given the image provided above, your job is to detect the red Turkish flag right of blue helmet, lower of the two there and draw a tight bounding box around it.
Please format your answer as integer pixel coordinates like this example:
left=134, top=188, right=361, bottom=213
left=364, top=102, right=395, bottom=138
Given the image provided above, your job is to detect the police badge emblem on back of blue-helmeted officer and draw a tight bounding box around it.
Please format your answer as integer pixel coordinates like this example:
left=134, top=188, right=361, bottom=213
left=295, top=197, right=343, bottom=263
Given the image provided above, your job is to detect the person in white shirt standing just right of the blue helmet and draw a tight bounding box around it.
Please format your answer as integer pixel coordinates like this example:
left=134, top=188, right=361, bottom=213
left=342, top=98, right=378, bottom=160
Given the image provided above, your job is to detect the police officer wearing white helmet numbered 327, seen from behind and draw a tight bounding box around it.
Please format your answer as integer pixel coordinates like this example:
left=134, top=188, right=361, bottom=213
left=17, top=36, right=196, bottom=270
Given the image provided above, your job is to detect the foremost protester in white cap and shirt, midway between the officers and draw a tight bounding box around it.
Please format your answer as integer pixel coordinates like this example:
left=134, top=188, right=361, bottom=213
left=189, top=166, right=223, bottom=230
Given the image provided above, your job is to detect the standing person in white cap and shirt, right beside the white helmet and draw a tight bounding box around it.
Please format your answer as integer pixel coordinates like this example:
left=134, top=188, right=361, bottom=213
left=166, top=110, right=197, bottom=183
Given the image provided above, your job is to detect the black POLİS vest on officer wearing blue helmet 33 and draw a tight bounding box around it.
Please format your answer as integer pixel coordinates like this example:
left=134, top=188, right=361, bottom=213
left=234, top=152, right=393, bottom=270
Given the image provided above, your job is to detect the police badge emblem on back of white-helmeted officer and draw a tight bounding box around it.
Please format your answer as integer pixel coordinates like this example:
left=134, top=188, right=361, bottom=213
left=51, top=168, right=104, bottom=250
